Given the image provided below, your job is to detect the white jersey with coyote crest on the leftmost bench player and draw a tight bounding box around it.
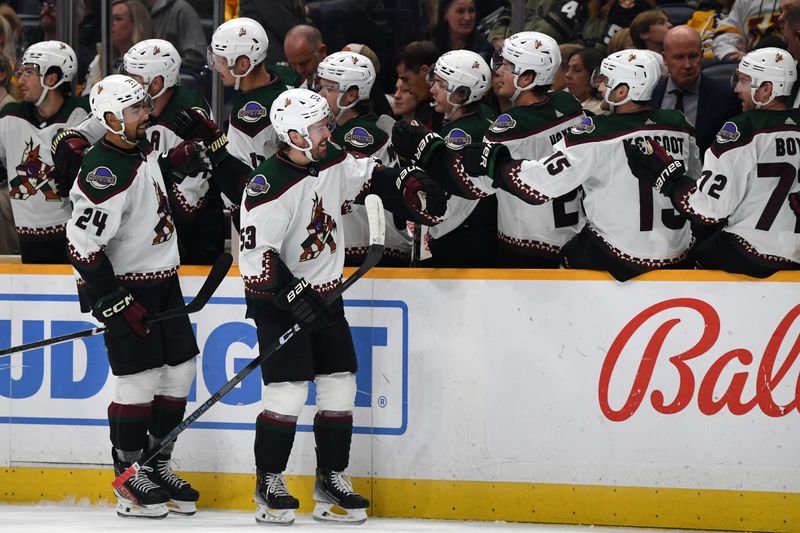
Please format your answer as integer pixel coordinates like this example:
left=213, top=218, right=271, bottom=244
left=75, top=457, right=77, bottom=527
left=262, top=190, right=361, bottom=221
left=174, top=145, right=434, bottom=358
left=0, top=97, right=88, bottom=239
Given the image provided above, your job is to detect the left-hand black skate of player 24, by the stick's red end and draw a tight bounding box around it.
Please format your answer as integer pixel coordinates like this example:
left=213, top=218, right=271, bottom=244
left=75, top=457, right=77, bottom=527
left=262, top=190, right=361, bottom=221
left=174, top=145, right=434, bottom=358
left=114, top=453, right=169, bottom=518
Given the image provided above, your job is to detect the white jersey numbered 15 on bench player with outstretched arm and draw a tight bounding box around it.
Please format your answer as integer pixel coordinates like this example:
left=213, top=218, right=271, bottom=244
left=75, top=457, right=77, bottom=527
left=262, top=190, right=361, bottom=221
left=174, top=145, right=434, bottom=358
left=509, top=109, right=699, bottom=267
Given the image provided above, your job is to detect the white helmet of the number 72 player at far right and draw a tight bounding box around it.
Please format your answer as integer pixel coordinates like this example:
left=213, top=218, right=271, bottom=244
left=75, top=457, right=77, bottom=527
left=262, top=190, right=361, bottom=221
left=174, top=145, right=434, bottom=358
left=738, top=48, right=797, bottom=109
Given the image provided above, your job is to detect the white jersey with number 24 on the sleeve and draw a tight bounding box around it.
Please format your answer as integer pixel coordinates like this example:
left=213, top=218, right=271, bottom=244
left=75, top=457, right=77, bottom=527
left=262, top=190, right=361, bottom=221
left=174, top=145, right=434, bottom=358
left=67, top=140, right=180, bottom=282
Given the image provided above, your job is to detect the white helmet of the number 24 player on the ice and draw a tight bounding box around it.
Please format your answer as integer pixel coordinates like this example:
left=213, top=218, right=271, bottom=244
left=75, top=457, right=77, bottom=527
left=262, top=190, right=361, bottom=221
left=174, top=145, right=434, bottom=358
left=89, top=74, right=153, bottom=140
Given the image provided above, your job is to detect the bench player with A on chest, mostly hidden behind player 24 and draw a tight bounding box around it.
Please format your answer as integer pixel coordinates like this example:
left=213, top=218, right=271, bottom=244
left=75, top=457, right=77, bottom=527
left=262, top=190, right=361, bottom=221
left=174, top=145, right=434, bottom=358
left=52, top=39, right=225, bottom=265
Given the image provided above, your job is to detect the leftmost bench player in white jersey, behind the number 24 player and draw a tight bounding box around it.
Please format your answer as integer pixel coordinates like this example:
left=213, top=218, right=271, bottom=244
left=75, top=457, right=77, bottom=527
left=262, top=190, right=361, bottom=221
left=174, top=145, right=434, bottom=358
left=0, top=41, right=88, bottom=263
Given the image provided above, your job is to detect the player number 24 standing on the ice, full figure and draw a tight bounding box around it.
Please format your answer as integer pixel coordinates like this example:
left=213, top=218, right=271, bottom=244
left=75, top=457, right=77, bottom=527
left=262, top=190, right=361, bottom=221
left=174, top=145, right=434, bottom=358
left=67, top=74, right=199, bottom=518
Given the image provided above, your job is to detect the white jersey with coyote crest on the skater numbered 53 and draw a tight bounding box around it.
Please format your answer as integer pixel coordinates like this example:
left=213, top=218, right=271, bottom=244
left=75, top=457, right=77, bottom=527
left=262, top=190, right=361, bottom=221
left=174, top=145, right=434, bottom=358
left=239, top=143, right=377, bottom=298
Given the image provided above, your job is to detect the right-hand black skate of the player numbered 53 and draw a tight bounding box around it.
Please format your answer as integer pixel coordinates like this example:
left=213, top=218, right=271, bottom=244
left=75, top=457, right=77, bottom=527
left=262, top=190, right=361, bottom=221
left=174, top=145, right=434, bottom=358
left=314, top=469, right=369, bottom=524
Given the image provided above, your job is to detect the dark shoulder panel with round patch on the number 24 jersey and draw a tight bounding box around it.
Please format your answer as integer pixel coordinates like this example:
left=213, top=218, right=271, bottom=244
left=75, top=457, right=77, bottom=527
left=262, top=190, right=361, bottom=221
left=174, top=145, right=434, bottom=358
left=77, top=140, right=144, bottom=204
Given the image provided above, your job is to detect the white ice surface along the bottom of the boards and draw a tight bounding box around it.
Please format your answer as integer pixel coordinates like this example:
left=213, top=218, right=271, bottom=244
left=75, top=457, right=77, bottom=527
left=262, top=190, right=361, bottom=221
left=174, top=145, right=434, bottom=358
left=0, top=505, right=732, bottom=533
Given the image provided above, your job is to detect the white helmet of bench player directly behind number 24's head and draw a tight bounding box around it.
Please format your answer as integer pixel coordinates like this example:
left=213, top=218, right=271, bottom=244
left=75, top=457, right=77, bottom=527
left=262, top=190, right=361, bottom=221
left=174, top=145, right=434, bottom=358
left=122, top=39, right=181, bottom=98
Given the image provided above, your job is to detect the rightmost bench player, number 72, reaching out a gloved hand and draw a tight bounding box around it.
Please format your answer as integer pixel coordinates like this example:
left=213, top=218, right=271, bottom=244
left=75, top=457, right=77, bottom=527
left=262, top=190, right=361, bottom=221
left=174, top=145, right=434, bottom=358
left=628, top=48, right=800, bottom=278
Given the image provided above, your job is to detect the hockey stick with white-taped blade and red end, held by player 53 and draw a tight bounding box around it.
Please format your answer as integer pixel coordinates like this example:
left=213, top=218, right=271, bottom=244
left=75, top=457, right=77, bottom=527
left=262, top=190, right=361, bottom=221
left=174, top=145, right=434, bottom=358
left=111, top=194, right=386, bottom=489
